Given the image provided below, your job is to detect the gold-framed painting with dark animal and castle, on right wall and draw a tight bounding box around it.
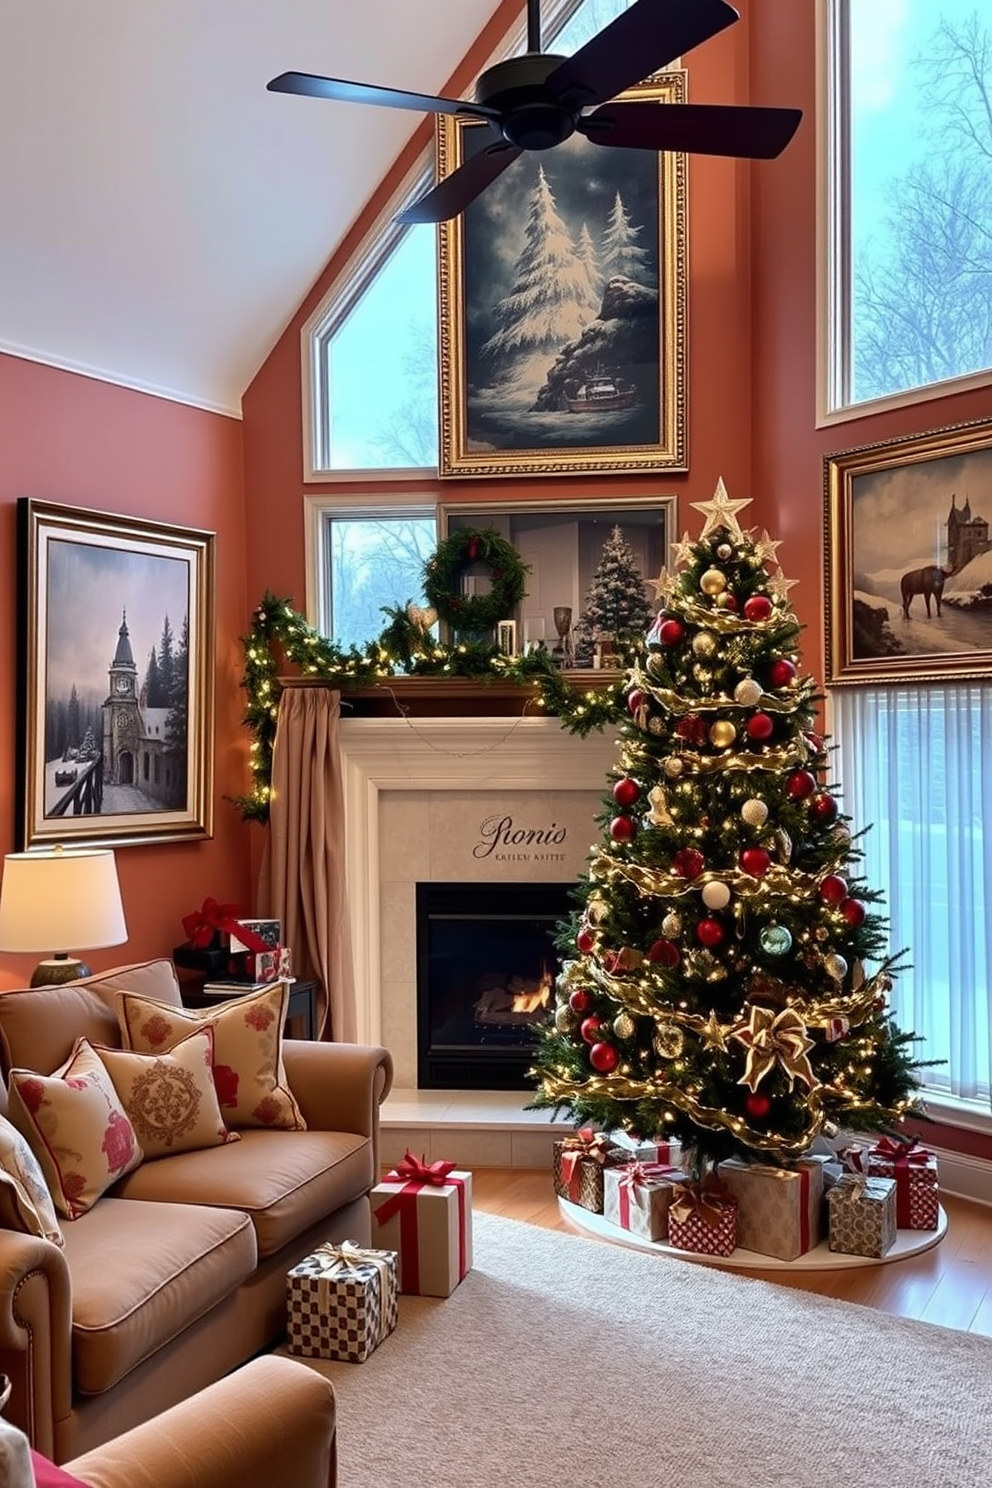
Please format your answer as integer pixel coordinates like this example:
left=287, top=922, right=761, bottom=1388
left=824, top=420, right=992, bottom=684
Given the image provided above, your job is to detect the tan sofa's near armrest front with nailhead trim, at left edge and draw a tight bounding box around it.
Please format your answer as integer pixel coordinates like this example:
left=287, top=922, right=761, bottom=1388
left=0, top=1229, right=73, bottom=1455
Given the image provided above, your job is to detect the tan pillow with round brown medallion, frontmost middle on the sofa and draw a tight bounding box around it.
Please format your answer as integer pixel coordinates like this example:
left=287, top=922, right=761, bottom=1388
left=95, top=1028, right=239, bottom=1158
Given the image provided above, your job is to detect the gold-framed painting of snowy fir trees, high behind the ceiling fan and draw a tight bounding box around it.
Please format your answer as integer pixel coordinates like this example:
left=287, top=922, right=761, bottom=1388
left=437, top=71, right=687, bottom=476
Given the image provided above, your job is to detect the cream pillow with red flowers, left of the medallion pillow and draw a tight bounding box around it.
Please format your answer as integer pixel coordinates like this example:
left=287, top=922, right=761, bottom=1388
left=9, top=1039, right=144, bottom=1219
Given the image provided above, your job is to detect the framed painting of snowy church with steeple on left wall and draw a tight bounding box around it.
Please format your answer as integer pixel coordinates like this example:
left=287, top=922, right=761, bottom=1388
left=18, top=498, right=213, bottom=848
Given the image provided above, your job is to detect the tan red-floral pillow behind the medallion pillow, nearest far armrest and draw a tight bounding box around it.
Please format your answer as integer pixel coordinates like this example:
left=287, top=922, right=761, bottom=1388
left=116, top=982, right=306, bottom=1131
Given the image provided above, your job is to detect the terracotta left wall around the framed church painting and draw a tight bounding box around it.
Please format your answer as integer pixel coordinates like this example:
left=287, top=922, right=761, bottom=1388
left=0, top=346, right=251, bottom=984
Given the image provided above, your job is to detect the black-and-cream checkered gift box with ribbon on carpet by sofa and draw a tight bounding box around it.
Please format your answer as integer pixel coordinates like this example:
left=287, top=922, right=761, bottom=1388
left=286, top=1241, right=399, bottom=1364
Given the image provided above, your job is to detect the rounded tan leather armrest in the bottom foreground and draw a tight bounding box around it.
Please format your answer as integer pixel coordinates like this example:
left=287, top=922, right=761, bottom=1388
left=65, top=1354, right=338, bottom=1488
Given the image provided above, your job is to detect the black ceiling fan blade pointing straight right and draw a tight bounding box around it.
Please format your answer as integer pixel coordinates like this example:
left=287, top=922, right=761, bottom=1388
left=579, top=103, right=803, bottom=161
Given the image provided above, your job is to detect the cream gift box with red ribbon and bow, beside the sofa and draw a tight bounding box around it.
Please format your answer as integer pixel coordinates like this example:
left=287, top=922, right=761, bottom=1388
left=370, top=1152, right=471, bottom=1298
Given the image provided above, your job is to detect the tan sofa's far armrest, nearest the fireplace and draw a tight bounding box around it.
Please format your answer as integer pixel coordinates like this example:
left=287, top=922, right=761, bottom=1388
left=283, top=1039, right=393, bottom=1173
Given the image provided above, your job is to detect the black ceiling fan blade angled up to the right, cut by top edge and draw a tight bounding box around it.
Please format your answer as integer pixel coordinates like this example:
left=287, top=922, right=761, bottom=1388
left=547, top=0, right=741, bottom=107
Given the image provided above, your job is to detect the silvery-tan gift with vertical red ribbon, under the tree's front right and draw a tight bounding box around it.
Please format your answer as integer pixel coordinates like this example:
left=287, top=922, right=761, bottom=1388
left=717, top=1158, right=824, bottom=1260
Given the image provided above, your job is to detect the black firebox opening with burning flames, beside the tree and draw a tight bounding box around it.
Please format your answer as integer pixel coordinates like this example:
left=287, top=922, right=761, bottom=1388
left=416, top=882, right=576, bottom=1091
